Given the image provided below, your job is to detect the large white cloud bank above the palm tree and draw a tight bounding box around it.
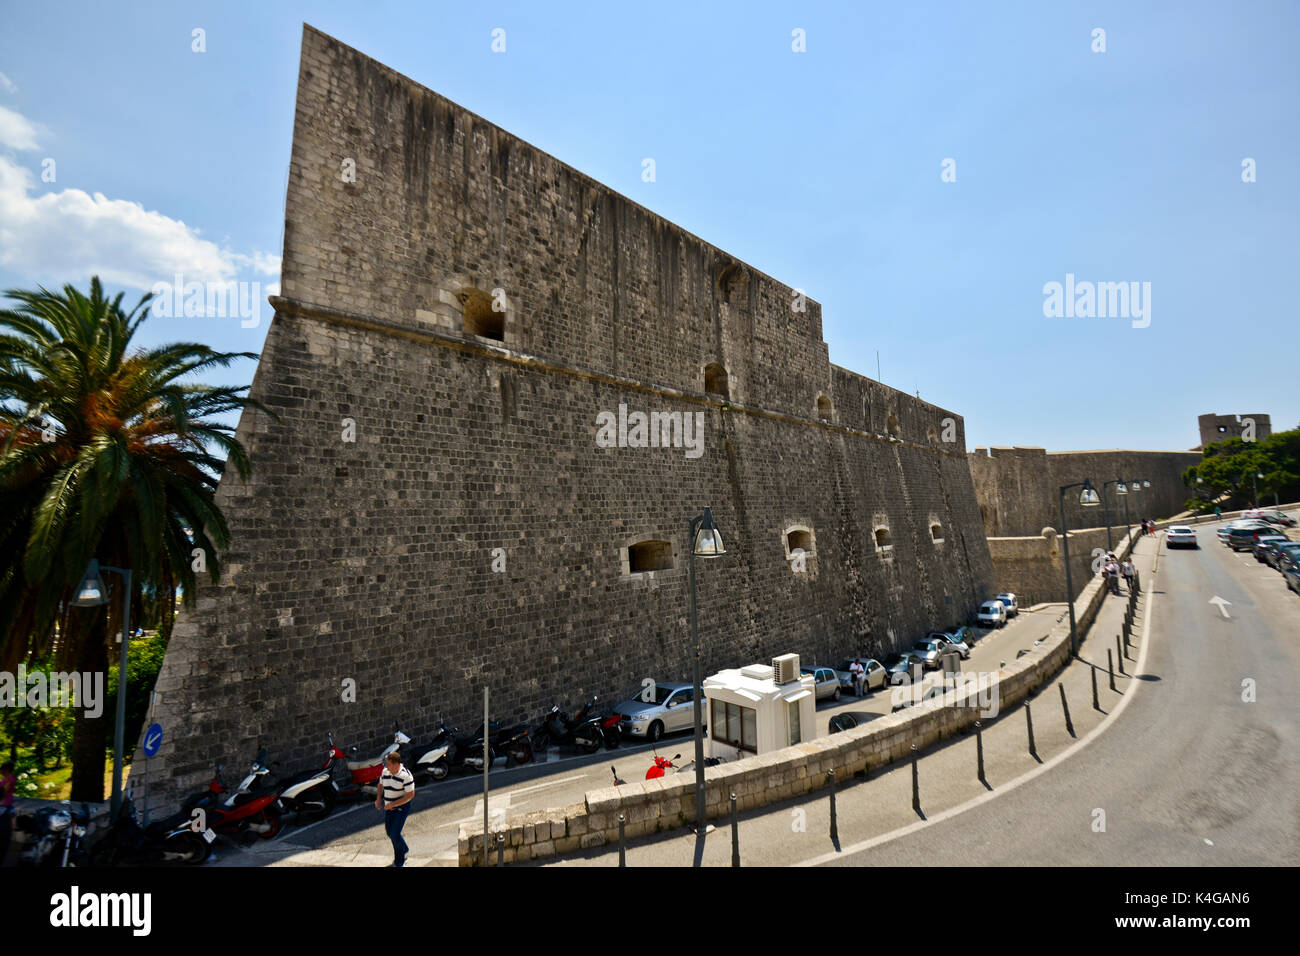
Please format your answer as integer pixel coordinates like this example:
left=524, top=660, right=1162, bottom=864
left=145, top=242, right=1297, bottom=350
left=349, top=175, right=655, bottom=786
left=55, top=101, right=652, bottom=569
left=0, top=107, right=280, bottom=290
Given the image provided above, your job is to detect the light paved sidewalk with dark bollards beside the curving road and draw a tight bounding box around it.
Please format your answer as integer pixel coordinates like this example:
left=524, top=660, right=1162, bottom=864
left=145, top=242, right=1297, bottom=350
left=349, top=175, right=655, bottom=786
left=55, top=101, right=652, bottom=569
left=527, top=536, right=1161, bottom=866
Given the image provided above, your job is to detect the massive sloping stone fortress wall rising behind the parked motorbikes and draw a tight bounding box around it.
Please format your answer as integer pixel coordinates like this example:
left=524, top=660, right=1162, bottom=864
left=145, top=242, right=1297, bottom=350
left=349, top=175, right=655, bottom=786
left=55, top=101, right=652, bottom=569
left=137, top=27, right=993, bottom=803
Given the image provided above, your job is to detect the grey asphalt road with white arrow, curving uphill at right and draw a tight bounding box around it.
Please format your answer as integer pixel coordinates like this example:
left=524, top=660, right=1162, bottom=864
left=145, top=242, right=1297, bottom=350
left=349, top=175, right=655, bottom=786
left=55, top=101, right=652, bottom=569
left=819, top=525, right=1300, bottom=866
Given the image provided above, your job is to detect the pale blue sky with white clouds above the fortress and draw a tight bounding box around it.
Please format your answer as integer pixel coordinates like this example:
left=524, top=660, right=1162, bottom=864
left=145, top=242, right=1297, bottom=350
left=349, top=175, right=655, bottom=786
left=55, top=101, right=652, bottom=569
left=0, top=0, right=1300, bottom=450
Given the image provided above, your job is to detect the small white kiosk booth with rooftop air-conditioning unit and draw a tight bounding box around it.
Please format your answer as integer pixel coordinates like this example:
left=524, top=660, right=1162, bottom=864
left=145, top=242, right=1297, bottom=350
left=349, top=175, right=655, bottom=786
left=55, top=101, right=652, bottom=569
left=703, top=654, right=816, bottom=760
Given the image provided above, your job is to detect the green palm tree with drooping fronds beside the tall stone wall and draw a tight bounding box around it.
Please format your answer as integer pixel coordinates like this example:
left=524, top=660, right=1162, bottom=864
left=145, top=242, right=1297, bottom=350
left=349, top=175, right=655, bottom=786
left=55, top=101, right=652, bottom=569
left=0, top=277, right=265, bottom=800
